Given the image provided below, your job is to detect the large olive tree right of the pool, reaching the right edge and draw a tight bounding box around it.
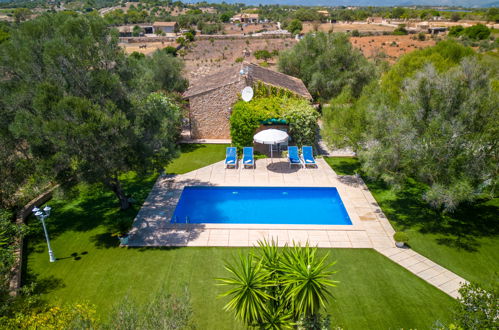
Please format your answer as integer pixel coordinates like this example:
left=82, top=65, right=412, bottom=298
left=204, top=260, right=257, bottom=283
left=360, top=58, right=499, bottom=210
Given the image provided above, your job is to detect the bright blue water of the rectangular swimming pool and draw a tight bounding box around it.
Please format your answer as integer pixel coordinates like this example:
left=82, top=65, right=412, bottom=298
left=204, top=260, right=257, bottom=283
left=171, top=186, right=352, bottom=225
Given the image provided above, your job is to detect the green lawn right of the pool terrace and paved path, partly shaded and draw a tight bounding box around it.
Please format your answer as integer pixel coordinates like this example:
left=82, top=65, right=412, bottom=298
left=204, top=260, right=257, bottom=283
left=326, top=157, right=499, bottom=287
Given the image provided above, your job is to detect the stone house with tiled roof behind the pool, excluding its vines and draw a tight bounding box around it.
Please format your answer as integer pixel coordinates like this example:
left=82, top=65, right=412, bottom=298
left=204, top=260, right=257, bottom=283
left=183, top=63, right=312, bottom=139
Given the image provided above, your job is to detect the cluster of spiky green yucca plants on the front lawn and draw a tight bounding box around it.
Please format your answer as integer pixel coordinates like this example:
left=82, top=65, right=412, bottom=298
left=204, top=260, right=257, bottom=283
left=218, top=240, right=338, bottom=329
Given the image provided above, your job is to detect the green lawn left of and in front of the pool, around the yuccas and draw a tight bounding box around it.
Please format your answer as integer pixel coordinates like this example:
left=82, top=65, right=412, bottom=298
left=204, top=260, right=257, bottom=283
left=25, top=146, right=455, bottom=329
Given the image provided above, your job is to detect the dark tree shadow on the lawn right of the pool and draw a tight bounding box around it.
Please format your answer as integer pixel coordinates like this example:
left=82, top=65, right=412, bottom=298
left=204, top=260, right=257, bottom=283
left=368, top=181, right=499, bottom=252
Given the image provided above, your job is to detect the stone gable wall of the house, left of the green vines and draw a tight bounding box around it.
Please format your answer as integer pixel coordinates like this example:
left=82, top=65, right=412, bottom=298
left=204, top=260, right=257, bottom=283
left=189, top=79, right=245, bottom=139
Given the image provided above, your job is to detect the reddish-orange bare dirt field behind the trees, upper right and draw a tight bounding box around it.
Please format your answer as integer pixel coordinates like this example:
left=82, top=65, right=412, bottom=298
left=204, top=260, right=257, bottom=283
left=350, top=35, right=435, bottom=63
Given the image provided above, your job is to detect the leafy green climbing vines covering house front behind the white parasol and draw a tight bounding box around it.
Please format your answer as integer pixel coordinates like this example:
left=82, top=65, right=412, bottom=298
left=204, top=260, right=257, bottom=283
left=230, top=96, right=319, bottom=148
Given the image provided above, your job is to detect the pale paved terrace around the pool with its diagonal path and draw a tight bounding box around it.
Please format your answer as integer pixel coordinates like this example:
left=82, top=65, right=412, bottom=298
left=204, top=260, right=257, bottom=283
left=128, top=158, right=466, bottom=297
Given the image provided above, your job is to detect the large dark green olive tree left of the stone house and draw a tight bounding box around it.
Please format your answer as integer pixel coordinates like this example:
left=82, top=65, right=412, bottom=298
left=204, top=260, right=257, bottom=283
left=0, top=13, right=185, bottom=209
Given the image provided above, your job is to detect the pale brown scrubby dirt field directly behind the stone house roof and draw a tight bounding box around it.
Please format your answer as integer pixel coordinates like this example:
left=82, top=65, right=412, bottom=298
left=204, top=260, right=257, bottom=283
left=184, top=39, right=296, bottom=80
